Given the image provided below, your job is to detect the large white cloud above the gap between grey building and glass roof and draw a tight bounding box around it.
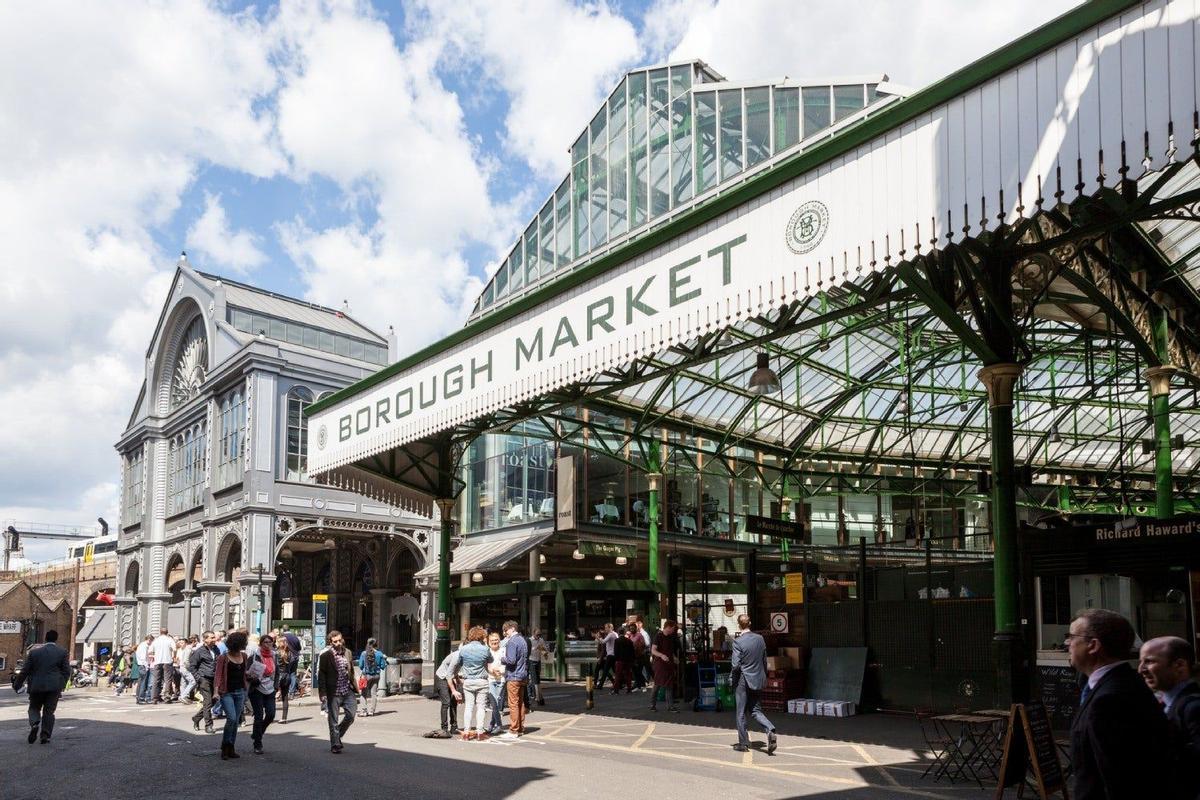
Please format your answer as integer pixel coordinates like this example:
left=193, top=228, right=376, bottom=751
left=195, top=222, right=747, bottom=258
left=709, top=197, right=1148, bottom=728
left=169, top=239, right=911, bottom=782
left=278, top=4, right=516, bottom=353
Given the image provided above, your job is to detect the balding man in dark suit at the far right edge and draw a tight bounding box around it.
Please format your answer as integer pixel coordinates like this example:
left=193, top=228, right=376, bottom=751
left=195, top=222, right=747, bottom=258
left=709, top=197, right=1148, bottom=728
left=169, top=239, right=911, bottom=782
left=1138, top=636, right=1200, bottom=798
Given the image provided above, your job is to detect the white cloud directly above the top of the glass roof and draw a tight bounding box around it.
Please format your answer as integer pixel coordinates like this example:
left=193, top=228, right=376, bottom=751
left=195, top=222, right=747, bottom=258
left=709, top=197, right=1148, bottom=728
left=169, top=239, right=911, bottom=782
left=644, top=0, right=1078, bottom=89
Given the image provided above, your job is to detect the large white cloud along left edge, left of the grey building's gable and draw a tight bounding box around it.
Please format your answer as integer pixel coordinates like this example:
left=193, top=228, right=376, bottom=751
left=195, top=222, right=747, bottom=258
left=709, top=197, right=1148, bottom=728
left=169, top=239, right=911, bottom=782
left=0, top=1, right=280, bottom=522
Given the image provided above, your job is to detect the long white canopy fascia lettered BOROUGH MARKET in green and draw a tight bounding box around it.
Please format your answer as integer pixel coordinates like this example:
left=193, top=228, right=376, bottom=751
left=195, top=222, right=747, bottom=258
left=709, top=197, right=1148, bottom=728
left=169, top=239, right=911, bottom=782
left=308, top=0, right=1198, bottom=482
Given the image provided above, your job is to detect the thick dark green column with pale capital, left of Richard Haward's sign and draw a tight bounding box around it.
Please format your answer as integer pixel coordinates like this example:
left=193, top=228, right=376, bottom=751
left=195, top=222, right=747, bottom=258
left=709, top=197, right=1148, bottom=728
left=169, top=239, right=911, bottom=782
left=979, top=363, right=1028, bottom=703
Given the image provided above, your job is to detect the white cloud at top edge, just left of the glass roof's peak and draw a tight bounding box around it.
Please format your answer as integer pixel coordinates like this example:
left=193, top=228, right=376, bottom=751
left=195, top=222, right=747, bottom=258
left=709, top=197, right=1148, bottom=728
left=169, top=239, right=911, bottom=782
left=416, top=0, right=640, bottom=179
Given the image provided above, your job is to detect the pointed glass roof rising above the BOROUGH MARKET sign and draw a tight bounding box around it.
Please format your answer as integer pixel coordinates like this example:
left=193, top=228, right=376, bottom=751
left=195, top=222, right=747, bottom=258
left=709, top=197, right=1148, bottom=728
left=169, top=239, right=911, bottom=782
left=468, top=61, right=901, bottom=323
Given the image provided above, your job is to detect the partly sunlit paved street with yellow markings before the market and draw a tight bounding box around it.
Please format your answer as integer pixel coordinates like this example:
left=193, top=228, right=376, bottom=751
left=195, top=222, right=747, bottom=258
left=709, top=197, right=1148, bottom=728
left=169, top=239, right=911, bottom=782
left=0, top=685, right=995, bottom=800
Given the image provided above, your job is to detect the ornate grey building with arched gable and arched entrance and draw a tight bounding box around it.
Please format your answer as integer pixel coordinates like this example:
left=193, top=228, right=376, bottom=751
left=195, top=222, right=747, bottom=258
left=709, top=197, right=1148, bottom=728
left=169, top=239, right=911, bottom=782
left=114, top=258, right=437, bottom=656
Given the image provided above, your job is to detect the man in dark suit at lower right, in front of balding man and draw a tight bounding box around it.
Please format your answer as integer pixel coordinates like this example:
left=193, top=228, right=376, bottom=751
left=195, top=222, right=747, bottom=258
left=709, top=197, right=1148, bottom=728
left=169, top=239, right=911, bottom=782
left=1066, top=608, right=1174, bottom=800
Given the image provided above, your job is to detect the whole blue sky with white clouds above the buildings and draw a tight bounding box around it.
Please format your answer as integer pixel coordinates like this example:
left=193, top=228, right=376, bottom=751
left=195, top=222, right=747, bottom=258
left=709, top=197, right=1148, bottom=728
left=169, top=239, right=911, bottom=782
left=0, top=0, right=1074, bottom=558
